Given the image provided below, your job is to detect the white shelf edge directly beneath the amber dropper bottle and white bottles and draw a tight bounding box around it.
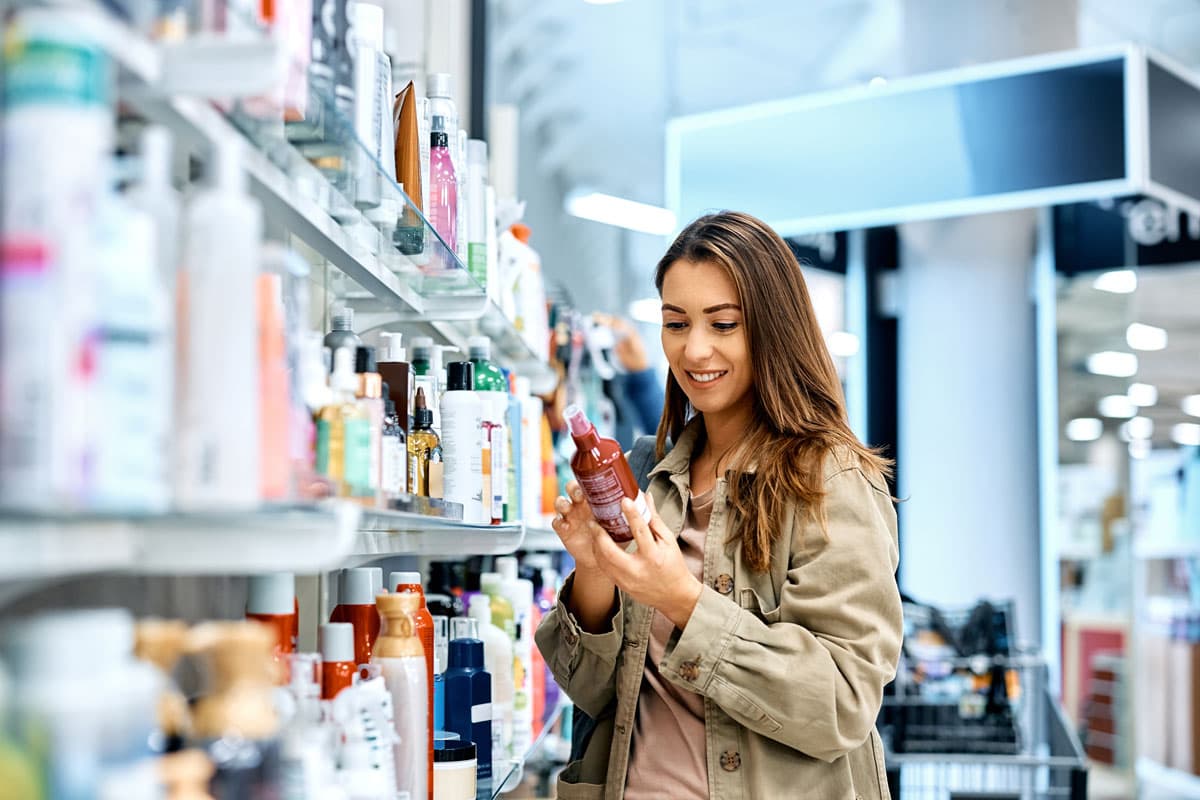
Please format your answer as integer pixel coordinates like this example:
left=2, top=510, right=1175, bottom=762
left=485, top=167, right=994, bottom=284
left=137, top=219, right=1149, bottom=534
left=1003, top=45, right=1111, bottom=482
left=347, top=509, right=524, bottom=564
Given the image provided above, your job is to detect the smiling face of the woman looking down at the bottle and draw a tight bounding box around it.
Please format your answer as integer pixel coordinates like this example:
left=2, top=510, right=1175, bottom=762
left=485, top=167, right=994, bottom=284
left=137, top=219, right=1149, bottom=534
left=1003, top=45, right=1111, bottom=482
left=662, top=259, right=754, bottom=415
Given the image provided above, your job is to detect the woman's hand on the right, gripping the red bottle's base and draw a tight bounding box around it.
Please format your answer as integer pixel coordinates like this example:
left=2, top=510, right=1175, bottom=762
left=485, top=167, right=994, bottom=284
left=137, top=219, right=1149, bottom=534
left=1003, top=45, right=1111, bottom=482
left=594, top=495, right=703, bottom=630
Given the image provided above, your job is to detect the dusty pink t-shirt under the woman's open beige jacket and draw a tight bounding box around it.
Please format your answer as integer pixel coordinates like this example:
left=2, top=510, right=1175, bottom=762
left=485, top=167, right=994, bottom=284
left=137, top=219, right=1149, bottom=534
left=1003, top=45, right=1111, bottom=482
left=625, top=489, right=713, bottom=800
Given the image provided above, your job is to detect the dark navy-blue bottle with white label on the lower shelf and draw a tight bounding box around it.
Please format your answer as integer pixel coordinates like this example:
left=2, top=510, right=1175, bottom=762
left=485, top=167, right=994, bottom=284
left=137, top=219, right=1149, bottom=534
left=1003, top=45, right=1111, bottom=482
left=443, top=619, right=492, bottom=781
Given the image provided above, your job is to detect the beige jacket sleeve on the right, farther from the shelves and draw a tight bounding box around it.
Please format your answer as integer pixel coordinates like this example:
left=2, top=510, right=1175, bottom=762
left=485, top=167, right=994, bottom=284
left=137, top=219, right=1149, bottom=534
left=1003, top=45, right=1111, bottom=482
left=659, top=469, right=902, bottom=762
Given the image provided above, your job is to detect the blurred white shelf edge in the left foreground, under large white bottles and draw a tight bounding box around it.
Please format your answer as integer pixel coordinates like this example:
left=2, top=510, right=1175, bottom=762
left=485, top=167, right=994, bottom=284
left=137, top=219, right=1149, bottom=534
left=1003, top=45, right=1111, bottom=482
left=0, top=503, right=360, bottom=581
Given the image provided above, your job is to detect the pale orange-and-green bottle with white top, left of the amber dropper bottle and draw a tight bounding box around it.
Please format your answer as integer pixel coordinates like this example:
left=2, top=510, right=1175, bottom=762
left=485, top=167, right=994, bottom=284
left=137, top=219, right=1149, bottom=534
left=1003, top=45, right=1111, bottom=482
left=317, top=348, right=371, bottom=497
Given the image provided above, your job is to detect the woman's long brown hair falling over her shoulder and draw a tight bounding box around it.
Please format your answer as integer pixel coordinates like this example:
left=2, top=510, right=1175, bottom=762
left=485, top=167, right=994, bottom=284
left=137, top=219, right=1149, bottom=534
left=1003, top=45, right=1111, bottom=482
left=654, top=211, right=892, bottom=572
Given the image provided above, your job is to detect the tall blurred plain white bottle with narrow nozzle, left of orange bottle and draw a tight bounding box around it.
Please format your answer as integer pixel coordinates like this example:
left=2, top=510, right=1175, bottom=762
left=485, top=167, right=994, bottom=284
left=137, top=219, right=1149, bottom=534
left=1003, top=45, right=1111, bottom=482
left=175, top=139, right=263, bottom=510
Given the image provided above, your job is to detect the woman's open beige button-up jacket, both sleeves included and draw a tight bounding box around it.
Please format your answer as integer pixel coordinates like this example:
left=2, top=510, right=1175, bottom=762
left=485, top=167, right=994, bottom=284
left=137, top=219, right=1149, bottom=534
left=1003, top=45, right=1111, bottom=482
left=536, top=426, right=902, bottom=800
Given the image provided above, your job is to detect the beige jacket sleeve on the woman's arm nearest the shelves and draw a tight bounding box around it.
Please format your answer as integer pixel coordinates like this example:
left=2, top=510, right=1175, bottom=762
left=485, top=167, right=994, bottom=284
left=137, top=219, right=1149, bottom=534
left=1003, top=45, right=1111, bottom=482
left=534, top=572, right=625, bottom=717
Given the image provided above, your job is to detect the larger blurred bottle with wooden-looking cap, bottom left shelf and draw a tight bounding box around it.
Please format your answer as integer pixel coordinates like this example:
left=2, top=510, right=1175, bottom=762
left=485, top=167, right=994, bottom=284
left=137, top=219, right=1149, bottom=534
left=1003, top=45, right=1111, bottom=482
left=188, top=622, right=280, bottom=798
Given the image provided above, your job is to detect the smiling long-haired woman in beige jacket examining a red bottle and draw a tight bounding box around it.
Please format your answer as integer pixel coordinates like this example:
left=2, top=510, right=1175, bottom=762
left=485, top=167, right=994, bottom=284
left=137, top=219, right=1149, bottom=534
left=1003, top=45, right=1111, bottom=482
left=536, top=212, right=901, bottom=800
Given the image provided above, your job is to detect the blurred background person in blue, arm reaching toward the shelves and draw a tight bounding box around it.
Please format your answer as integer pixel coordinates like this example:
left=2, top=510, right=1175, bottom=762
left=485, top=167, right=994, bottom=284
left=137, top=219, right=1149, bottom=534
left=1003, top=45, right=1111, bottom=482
left=592, top=313, right=662, bottom=450
